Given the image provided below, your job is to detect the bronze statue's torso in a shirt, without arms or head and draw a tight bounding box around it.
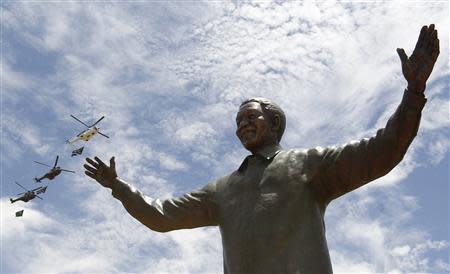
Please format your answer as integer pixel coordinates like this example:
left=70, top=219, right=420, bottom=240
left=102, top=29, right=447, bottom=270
left=216, top=151, right=332, bottom=273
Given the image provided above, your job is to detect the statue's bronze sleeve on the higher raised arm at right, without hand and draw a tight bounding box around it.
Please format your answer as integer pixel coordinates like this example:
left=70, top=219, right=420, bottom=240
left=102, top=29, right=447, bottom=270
left=306, top=90, right=426, bottom=203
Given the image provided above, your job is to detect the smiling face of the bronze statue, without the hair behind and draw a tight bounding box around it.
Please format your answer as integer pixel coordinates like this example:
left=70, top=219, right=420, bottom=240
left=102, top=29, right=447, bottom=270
left=236, top=102, right=276, bottom=152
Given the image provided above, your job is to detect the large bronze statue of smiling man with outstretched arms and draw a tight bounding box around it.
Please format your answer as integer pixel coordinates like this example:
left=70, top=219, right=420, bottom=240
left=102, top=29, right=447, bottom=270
left=84, top=25, right=439, bottom=274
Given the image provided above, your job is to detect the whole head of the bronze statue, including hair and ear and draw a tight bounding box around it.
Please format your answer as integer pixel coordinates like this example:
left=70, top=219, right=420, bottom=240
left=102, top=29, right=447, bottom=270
left=236, top=98, right=286, bottom=153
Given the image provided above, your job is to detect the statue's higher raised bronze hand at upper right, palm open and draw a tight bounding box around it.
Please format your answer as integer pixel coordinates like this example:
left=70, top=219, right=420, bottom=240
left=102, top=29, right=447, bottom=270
left=397, top=24, right=439, bottom=93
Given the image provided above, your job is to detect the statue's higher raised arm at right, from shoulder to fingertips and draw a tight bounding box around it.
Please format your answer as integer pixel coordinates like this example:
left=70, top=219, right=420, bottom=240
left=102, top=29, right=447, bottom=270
left=302, top=25, right=439, bottom=204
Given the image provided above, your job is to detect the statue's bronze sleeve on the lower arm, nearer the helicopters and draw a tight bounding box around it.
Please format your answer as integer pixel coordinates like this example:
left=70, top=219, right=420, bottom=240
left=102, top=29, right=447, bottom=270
left=112, top=179, right=218, bottom=232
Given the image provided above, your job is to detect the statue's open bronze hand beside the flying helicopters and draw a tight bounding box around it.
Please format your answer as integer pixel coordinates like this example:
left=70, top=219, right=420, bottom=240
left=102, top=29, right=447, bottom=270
left=84, top=157, right=117, bottom=188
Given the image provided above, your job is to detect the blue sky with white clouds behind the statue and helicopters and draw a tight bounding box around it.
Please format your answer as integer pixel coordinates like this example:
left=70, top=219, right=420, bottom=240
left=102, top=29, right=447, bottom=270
left=0, top=1, right=450, bottom=273
